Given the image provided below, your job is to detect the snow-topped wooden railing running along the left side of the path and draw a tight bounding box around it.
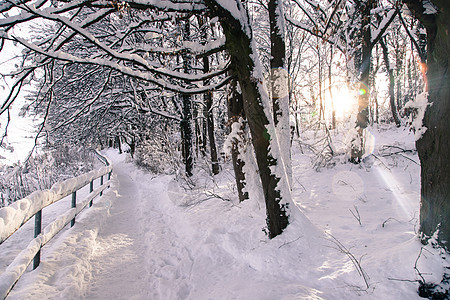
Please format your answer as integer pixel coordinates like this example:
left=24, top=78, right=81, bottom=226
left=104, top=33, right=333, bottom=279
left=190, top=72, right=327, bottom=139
left=0, top=152, right=112, bottom=299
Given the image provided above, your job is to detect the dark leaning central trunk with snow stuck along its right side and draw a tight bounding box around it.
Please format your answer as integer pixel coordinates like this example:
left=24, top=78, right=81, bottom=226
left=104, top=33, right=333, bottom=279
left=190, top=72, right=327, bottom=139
left=205, top=0, right=291, bottom=238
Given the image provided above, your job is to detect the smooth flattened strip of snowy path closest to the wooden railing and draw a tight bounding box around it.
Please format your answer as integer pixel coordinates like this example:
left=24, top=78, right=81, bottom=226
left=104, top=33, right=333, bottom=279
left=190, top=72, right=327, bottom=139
left=87, top=166, right=149, bottom=299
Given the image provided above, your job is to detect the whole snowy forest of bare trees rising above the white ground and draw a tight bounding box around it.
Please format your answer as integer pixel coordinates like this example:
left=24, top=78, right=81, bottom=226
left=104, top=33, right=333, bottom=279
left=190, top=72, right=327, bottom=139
left=0, top=0, right=450, bottom=299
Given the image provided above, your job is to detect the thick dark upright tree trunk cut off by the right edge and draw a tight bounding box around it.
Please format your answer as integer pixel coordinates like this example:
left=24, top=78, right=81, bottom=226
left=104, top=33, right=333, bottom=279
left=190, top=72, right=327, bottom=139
left=404, top=0, right=450, bottom=251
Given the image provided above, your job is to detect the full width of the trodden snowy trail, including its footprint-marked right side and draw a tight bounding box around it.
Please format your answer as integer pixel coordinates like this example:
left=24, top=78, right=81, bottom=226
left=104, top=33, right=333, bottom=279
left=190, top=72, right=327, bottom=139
left=86, top=154, right=198, bottom=299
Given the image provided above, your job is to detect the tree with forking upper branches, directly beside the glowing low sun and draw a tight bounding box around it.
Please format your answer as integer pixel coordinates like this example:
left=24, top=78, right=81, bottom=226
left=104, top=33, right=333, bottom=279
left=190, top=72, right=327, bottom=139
left=288, top=0, right=398, bottom=163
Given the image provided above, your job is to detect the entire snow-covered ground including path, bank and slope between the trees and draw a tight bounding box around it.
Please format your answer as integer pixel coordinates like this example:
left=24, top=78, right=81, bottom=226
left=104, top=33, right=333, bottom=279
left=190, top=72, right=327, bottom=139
left=0, top=124, right=448, bottom=299
